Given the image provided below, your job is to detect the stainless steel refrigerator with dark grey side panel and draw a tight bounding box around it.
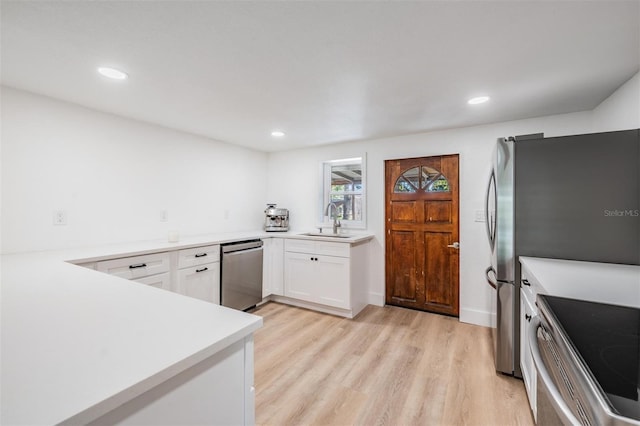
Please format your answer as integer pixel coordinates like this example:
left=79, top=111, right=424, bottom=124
left=486, top=129, right=640, bottom=377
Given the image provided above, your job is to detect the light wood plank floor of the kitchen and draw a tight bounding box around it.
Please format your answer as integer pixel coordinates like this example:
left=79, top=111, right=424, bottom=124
left=253, top=302, right=533, bottom=426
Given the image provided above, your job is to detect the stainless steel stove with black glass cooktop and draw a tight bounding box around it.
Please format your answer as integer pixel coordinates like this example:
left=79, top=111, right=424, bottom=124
left=528, top=295, right=640, bottom=426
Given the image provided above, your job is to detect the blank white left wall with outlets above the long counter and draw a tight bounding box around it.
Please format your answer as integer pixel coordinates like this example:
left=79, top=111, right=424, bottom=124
left=1, top=87, right=267, bottom=253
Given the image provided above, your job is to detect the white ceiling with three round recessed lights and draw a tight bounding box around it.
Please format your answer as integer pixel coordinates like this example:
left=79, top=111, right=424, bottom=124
left=0, top=0, right=640, bottom=151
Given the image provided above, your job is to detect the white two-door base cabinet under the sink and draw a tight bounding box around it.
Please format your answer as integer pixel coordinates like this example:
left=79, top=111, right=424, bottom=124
left=277, top=239, right=368, bottom=318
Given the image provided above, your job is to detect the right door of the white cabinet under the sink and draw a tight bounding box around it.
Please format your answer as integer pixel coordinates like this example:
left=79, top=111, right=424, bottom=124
left=315, top=256, right=351, bottom=309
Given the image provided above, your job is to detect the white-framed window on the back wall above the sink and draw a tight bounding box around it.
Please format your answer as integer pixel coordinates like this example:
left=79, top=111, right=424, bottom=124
left=320, top=156, right=366, bottom=229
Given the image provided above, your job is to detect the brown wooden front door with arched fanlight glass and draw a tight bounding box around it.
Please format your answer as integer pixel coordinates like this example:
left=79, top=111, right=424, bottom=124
left=385, top=154, right=459, bottom=316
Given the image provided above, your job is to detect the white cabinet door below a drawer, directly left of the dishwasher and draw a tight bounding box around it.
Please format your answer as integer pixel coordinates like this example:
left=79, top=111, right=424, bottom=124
left=178, top=262, right=220, bottom=305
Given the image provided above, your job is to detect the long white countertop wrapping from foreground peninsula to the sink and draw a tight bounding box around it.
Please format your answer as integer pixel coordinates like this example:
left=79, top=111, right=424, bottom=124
left=0, top=231, right=373, bottom=424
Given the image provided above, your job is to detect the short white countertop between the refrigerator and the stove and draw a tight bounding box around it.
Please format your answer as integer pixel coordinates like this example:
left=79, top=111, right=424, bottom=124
left=520, top=256, right=640, bottom=307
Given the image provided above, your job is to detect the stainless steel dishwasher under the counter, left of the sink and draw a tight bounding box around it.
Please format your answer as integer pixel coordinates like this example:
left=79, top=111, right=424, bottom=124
left=220, top=240, right=262, bottom=311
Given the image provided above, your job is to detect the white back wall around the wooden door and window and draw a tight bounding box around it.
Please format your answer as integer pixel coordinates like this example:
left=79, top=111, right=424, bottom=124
left=268, top=72, right=640, bottom=325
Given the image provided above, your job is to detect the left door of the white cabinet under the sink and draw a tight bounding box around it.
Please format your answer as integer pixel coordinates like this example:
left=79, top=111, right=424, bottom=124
left=284, top=252, right=318, bottom=302
